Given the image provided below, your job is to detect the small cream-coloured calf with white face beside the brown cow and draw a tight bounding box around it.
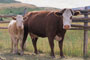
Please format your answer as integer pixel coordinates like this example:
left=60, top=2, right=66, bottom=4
left=8, top=15, right=24, bottom=54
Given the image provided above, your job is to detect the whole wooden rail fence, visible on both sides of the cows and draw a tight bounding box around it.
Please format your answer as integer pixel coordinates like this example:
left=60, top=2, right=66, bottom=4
left=0, top=7, right=90, bottom=57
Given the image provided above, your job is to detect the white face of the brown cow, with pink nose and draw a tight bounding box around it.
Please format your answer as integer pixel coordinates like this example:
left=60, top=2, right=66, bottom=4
left=63, top=9, right=72, bottom=29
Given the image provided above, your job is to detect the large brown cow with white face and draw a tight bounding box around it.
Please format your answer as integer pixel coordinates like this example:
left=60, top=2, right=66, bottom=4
left=22, top=9, right=79, bottom=57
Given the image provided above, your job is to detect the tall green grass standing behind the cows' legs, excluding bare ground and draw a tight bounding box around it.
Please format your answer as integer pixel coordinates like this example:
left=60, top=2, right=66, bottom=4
left=0, top=30, right=90, bottom=56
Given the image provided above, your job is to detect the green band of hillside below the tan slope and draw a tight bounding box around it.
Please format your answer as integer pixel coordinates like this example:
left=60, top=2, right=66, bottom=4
left=0, top=7, right=44, bottom=15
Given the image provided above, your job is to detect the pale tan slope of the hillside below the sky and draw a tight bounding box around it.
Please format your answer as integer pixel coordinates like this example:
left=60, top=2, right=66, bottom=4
left=0, top=3, right=57, bottom=10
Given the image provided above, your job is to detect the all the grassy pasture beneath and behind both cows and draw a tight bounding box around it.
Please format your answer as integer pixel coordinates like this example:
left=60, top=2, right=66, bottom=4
left=0, top=24, right=90, bottom=60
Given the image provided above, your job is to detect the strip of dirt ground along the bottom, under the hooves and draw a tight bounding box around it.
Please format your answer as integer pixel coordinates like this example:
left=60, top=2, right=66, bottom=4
left=0, top=52, right=90, bottom=60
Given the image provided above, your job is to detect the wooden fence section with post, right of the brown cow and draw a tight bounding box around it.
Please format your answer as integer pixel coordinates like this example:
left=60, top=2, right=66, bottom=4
left=71, top=7, right=90, bottom=57
